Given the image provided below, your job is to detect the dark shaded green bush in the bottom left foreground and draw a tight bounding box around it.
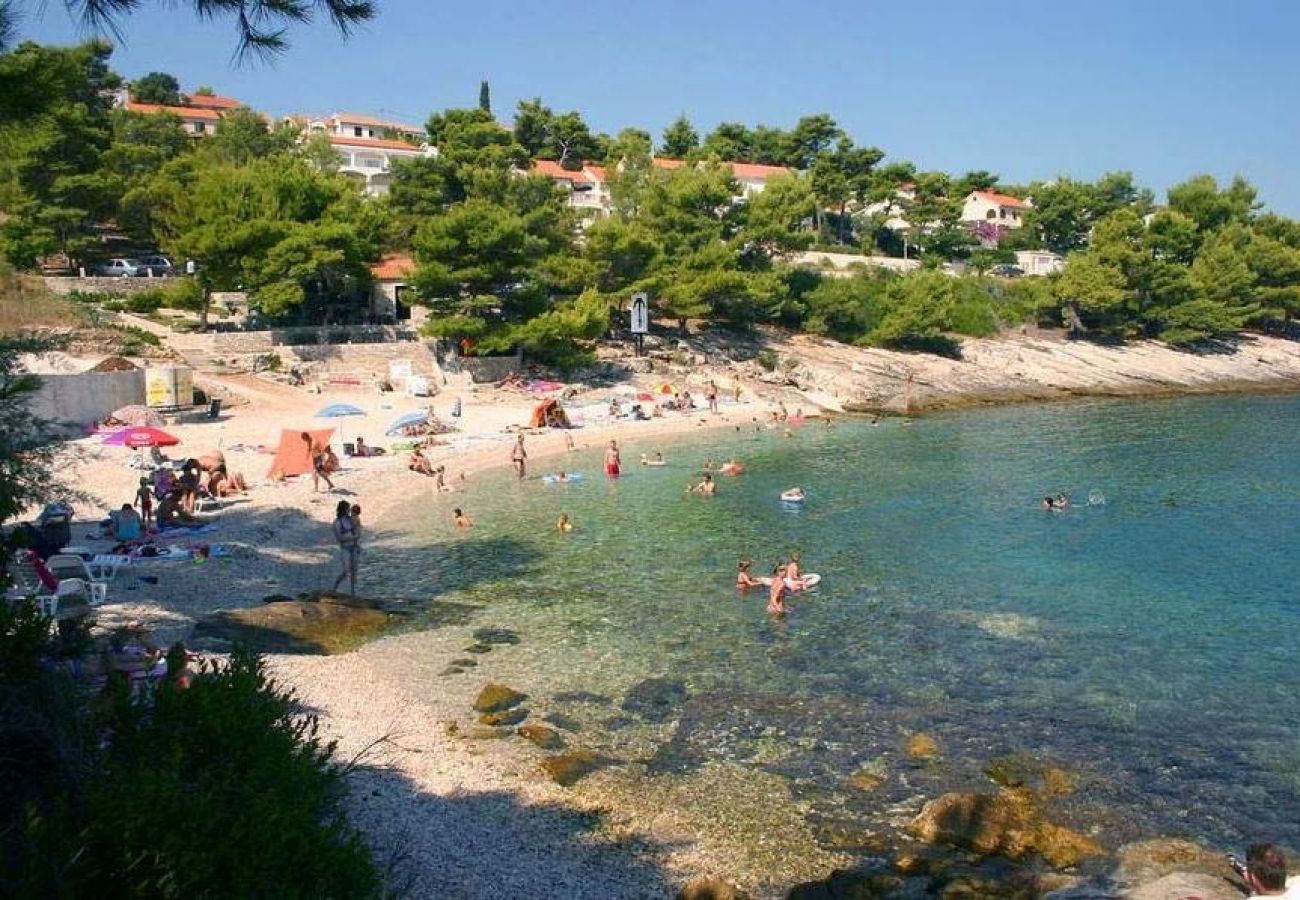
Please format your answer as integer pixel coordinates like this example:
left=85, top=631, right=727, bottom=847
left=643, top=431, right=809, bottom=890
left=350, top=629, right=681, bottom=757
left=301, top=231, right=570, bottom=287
left=0, top=621, right=380, bottom=897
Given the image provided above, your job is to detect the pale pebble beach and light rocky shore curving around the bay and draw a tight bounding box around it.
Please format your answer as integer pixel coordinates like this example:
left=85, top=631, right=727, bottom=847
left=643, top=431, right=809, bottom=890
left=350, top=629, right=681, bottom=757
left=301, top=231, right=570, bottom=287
left=38, top=338, right=1300, bottom=897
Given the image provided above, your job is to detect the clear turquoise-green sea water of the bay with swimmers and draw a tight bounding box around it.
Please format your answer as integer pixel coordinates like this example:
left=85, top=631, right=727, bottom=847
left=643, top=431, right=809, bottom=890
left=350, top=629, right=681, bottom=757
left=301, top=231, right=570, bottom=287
left=367, top=395, right=1300, bottom=847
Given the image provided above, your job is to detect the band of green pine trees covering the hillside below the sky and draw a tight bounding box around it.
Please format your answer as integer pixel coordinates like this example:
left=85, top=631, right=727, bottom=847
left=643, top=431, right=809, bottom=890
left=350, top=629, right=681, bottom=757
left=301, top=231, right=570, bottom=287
left=0, top=42, right=1300, bottom=365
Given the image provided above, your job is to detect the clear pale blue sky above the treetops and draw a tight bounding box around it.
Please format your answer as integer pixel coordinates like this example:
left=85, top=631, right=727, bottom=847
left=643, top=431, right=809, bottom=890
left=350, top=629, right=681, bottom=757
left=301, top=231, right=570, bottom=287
left=20, top=0, right=1300, bottom=217
